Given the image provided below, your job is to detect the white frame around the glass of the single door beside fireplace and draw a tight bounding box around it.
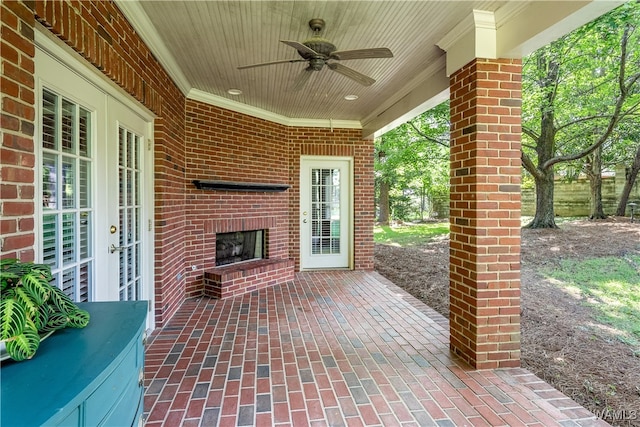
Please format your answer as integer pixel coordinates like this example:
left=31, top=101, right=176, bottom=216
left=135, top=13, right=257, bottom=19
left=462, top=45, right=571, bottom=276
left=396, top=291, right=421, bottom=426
left=298, top=156, right=354, bottom=271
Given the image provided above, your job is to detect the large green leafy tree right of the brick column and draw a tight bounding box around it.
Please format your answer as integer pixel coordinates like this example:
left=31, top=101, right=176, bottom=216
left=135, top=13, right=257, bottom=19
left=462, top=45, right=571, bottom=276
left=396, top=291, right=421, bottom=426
left=522, top=1, right=640, bottom=228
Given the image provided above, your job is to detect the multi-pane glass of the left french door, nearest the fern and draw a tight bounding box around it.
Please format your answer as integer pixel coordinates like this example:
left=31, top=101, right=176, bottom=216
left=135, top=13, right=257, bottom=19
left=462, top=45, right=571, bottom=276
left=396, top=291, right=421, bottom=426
left=39, top=89, right=95, bottom=301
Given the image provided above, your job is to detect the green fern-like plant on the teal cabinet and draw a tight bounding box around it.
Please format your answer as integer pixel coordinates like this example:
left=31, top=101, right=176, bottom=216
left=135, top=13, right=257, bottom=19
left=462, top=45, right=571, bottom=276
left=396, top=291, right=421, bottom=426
left=0, top=259, right=89, bottom=361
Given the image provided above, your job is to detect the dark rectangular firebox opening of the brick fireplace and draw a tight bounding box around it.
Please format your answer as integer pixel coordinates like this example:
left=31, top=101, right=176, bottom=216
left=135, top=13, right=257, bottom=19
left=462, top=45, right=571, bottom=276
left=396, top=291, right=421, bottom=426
left=216, top=230, right=265, bottom=266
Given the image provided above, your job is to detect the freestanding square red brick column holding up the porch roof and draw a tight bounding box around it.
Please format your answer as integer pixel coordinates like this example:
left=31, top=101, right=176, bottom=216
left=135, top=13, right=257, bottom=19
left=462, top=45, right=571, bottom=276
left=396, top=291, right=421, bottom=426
left=449, top=59, right=522, bottom=369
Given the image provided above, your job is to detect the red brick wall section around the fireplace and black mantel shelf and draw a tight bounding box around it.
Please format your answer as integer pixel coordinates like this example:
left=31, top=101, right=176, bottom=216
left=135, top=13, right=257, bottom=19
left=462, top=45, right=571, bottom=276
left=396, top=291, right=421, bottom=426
left=185, top=100, right=290, bottom=295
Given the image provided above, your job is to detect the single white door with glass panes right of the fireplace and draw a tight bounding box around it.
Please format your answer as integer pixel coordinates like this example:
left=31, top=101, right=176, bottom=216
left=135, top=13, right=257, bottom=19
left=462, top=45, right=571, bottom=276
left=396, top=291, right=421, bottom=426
left=300, top=157, right=352, bottom=270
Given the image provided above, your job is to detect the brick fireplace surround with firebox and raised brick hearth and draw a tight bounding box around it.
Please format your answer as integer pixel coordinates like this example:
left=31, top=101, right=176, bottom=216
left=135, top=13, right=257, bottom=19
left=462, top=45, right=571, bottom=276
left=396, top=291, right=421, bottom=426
left=204, top=217, right=294, bottom=298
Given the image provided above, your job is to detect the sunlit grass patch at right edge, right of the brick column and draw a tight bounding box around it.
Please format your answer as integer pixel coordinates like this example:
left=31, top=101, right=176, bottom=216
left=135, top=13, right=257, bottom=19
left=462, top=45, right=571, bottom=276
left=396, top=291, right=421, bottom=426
left=541, top=255, right=640, bottom=347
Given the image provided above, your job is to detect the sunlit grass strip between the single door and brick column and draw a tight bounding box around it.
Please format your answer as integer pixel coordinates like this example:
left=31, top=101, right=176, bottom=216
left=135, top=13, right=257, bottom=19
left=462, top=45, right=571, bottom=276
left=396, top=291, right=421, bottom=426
left=373, top=222, right=449, bottom=247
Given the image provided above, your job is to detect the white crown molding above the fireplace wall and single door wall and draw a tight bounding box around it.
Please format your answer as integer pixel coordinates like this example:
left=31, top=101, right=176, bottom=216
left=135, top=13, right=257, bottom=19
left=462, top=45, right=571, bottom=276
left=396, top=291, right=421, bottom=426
left=187, top=89, right=362, bottom=129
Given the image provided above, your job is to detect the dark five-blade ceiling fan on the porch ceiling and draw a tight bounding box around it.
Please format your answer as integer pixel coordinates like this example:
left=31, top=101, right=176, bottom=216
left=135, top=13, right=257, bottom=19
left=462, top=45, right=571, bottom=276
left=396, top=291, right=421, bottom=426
left=238, top=18, right=393, bottom=91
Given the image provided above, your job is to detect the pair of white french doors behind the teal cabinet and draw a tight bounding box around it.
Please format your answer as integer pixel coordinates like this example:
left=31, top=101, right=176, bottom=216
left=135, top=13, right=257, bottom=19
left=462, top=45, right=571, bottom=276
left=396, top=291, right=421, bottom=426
left=36, top=41, right=153, bottom=320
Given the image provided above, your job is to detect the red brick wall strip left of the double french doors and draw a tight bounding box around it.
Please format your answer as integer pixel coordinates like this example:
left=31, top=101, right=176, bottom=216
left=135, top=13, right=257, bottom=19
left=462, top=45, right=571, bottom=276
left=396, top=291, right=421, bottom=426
left=0, top=1, right=35, bottom=261
